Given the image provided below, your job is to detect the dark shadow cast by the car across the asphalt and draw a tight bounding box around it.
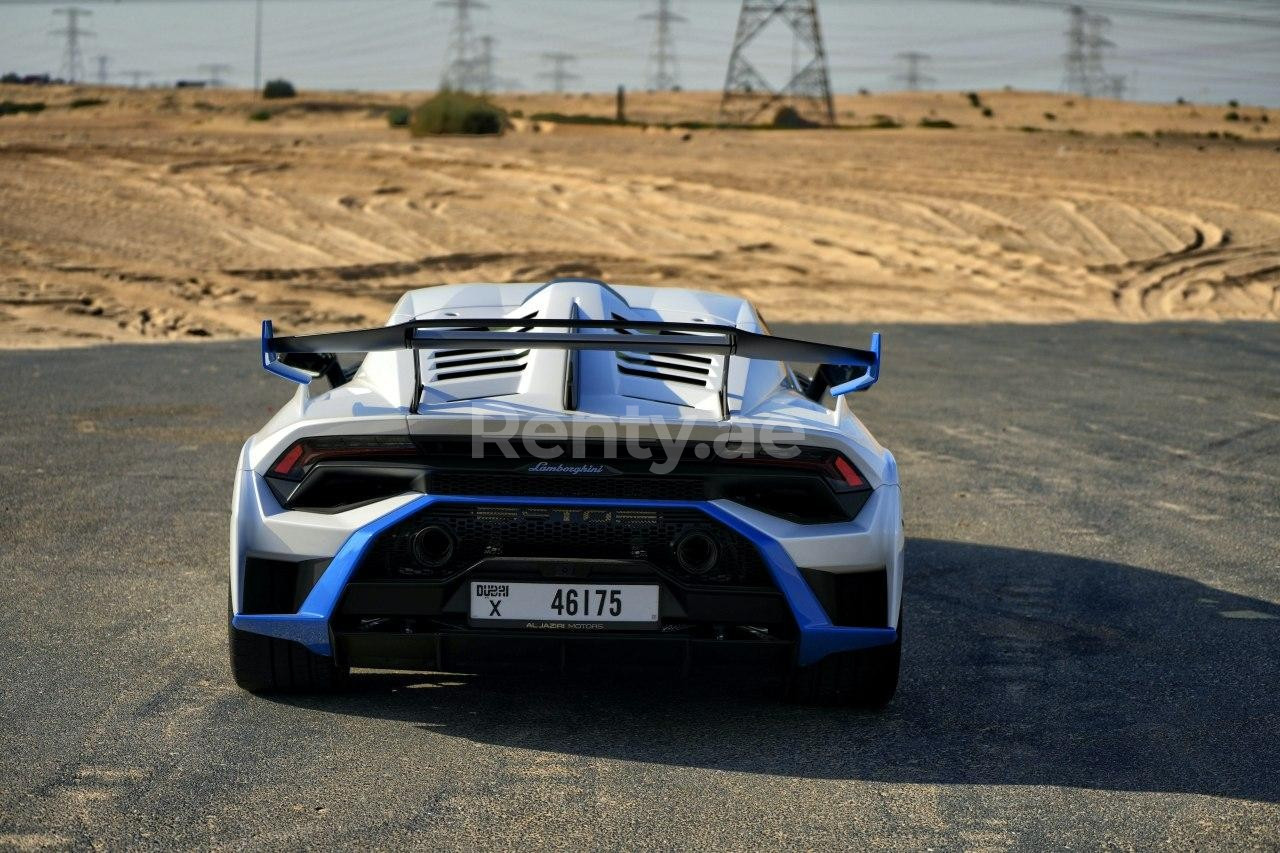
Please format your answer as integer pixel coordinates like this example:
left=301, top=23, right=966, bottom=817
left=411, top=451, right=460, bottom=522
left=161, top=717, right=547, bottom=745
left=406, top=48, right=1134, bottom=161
left=264, top=539, right=1280, bottom=802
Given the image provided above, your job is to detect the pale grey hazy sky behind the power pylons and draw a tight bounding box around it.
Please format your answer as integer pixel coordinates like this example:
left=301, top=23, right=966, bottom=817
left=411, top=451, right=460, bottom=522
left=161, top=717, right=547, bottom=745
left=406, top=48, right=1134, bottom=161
left=0, top=0, right=1280, bottom=106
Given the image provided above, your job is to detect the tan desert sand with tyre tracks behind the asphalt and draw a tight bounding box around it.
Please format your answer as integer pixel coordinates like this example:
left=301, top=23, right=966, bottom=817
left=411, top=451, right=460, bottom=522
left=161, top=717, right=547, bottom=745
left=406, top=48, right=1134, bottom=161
left=0, top=86, right=1280, bottom=347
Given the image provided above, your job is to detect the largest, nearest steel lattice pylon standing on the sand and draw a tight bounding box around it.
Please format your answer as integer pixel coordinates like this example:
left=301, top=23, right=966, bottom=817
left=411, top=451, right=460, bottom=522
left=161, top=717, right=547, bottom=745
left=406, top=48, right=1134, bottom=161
left=721, top=0, right=836, bottom=124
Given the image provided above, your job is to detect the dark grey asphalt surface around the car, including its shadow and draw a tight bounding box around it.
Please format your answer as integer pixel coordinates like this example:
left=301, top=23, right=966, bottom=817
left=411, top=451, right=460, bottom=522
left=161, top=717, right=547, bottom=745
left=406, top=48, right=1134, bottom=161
left=0, top=324, right=1280, bottom=849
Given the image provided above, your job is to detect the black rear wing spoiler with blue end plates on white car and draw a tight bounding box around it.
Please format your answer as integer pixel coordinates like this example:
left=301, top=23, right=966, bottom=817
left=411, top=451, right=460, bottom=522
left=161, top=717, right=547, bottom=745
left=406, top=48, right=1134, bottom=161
left=262, top=318, right=881, bottom=412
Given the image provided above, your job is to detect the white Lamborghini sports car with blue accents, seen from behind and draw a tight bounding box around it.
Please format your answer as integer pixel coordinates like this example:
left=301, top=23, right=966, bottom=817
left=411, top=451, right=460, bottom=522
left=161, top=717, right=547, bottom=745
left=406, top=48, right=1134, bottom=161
left=229, top=279, right=902, bottom=706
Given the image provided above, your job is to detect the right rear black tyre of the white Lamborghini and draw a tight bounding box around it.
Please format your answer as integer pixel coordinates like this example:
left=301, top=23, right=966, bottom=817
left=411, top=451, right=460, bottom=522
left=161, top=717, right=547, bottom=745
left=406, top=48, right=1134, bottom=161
left=791, top=612, right=902, bottom=708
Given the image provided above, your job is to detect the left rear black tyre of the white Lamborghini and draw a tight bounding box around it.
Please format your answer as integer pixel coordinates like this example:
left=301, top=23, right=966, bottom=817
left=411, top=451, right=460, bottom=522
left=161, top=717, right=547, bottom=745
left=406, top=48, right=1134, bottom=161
left=227, top=594, right=349, bottom=693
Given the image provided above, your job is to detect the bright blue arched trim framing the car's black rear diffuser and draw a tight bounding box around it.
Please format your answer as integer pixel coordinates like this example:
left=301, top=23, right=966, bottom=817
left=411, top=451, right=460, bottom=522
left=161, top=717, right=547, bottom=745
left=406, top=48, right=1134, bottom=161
left=232, top=494, right=897, bottom=665
